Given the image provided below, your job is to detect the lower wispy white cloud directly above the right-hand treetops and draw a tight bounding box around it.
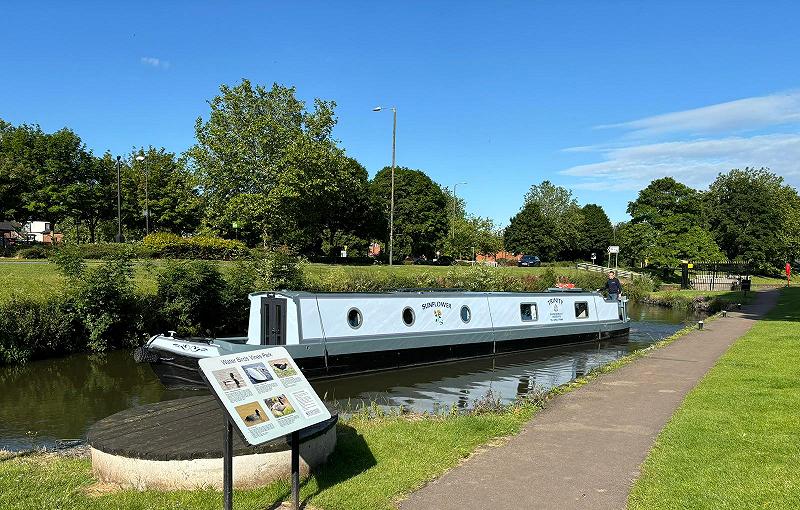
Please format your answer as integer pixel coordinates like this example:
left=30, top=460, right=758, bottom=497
left=560, top=133, right=800, bottom=191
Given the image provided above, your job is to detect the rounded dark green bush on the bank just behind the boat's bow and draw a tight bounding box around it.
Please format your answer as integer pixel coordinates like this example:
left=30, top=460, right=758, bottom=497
left=158, top=260, right=225, bottom=336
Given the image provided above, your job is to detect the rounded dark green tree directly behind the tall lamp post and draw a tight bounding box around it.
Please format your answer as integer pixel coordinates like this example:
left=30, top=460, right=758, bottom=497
left=370, top=167, right=449, bottom=258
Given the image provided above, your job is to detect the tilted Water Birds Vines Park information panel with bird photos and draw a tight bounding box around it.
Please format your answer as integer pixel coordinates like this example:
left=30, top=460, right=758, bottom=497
left=199, top=347, right=331, bottom=446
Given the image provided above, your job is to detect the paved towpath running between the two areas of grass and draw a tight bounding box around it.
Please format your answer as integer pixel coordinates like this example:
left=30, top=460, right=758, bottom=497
left=400, top=291, right=778, bottom=510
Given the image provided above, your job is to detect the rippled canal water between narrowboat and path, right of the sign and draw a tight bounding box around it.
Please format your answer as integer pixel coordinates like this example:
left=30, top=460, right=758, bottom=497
left=313, top=306, right=696, bottom=412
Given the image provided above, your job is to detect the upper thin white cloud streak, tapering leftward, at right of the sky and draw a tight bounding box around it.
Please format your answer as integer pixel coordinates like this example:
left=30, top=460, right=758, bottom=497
left=597, top=91, right=800, bottom=137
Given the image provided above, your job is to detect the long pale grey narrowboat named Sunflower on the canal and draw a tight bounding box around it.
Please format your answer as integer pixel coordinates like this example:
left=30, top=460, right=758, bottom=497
left=134, top=288, right=629, bottom=387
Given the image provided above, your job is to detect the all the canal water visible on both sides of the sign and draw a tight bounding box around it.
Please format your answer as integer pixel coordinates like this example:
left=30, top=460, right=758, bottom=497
left=0, top=305, right=696, bottom=451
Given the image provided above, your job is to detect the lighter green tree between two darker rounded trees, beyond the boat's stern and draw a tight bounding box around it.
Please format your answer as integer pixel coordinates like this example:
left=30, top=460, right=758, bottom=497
left=525, top=181, right=584, bottom=260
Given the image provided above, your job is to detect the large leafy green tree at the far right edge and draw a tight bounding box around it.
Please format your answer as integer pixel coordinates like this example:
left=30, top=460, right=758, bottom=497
left=706, top=168, right=799, bottom=271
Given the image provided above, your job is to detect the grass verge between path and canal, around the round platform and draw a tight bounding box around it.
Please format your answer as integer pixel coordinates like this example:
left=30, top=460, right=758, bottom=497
left=0, top=312, right=712, bottom=510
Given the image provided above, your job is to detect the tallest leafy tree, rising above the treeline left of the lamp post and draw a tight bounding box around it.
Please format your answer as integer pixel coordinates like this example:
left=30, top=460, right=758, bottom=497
left=187, top=80, right=338, bottom=242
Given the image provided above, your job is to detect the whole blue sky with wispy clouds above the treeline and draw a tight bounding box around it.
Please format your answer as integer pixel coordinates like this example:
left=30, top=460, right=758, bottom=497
left=0, top=1, right=800, bottom=225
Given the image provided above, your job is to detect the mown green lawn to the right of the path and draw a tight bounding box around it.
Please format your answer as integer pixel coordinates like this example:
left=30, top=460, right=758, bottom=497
left=628, top=288, right=800, bottom=510
